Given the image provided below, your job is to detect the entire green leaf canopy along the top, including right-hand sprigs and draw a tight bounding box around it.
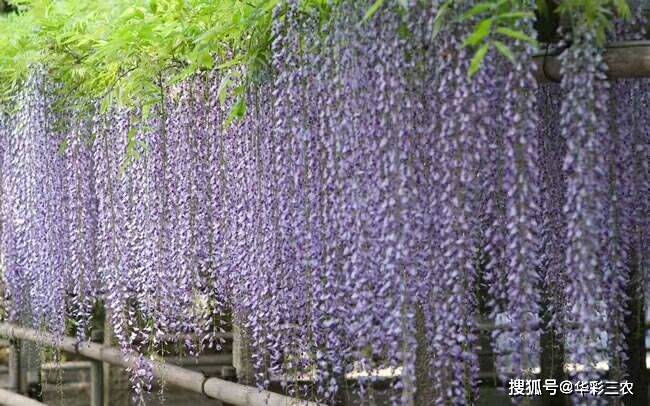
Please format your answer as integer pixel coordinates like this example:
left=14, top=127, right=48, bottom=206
left=0, top=0, right=630, bottom=109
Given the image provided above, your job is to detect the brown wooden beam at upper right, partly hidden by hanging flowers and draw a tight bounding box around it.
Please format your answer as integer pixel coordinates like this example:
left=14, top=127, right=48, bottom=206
left=533, top=41, right=650, bottom=82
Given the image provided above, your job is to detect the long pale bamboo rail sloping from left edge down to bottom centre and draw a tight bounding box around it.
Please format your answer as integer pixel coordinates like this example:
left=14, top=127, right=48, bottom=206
left=0, top=323, right=319, bottom=406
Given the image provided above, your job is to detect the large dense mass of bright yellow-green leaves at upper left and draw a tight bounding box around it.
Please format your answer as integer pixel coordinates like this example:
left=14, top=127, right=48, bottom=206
left=0, top=0, right=286, bottom=116
